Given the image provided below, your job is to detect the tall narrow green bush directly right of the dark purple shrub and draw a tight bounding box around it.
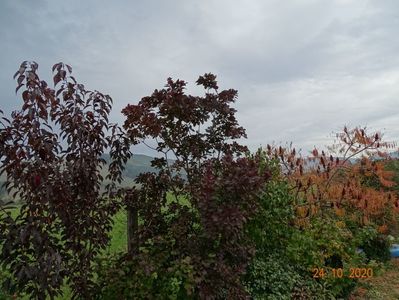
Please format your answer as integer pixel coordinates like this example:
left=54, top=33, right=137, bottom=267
left=243, top=156, right=301, bottom=299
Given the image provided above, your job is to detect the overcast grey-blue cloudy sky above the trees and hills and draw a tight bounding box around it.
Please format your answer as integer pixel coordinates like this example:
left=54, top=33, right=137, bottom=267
left=0, top=0, right=399, bottom=156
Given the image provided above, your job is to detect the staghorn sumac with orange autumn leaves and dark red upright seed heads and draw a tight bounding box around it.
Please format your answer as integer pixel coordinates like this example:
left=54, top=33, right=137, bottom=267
left=267, top=126, right=398, bottom=231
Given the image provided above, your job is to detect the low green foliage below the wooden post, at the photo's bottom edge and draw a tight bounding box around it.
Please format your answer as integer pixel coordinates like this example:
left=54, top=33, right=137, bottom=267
left=96, top=247, right=195, bottom=300
